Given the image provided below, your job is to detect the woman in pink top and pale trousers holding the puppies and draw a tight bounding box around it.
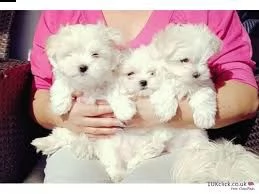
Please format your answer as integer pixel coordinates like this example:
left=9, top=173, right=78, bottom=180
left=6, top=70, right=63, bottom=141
left=31, top=10, right=258, bottom=183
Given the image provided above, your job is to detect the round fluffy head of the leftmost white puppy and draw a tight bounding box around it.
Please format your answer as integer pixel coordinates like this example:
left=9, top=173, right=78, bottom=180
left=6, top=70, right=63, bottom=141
left=46, top=24, right=121, bottom=85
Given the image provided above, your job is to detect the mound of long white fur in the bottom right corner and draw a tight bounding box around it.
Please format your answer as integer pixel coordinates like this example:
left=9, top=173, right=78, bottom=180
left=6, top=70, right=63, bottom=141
left=171, top=140, right=259, bottom=183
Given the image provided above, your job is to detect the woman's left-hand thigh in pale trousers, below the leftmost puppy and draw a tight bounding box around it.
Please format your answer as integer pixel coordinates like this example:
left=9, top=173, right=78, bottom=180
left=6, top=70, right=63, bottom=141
left=44, top=148, right=110, bottom=183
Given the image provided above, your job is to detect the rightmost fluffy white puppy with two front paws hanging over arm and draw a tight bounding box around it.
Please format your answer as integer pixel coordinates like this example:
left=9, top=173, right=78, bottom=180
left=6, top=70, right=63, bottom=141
left=151, top=24, right=221, bottom=128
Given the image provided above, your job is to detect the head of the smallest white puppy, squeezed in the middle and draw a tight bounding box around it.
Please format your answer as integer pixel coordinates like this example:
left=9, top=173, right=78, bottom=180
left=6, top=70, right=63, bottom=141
left=119, top=46, right=166, bottom=96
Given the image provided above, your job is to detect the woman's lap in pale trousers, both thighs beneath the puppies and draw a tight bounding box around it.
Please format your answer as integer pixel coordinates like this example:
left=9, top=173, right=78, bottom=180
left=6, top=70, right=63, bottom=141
left=44, top=148, right=175, bottom=183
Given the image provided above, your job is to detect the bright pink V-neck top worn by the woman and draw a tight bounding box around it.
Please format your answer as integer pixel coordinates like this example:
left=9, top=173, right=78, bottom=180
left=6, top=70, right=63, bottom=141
left=31, top=10, right=257, bottom=89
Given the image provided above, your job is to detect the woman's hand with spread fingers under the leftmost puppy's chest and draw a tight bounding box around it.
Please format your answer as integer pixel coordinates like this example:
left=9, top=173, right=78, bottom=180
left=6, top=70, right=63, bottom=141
left=61, top=92, right=124, bottom=137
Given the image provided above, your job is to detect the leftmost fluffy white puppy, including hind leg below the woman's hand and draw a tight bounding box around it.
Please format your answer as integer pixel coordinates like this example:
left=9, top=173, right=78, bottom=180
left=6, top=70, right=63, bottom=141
left=32, top=24, right=135, bottom=164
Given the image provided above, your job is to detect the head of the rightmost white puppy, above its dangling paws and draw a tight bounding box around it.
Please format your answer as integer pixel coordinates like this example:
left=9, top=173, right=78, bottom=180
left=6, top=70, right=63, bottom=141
left=153, top=24, right=221, bottom=83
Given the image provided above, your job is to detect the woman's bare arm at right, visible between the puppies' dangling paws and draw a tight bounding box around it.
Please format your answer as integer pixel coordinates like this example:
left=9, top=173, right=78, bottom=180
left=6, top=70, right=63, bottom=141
left=132, top=80, right=258, bottom=128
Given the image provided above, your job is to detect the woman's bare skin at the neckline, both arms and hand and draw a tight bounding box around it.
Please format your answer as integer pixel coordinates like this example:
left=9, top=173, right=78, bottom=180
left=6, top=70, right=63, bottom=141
left=32, top=11, right=258, bottom=137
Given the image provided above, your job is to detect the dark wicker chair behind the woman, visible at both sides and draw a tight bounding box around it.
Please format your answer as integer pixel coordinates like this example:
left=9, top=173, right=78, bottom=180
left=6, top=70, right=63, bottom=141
left=0, top=11, right=259, bottom=182
